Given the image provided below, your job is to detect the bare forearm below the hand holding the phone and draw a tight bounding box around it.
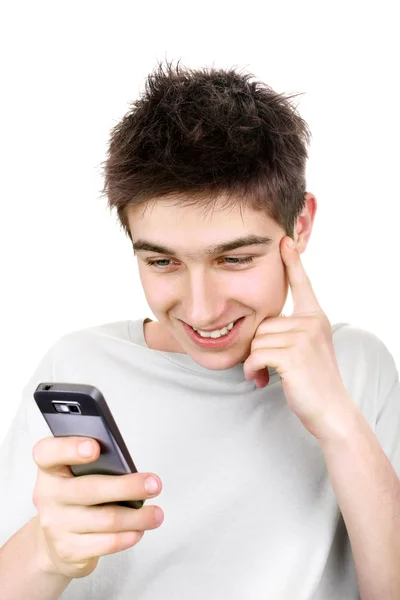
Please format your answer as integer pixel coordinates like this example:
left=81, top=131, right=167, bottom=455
left=0, top=518, right=71, bottom=600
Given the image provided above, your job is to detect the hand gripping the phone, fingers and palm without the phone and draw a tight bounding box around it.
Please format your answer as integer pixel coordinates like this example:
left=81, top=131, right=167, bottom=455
left=33, top=436, right=164, bottom=578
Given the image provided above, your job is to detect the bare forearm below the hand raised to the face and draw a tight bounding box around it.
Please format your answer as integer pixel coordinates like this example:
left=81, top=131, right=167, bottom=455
left=319, top=407, right=400, bottom=600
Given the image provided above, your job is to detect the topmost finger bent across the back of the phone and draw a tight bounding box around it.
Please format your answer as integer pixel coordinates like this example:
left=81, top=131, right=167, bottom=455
left=32, top=436, right=100, bottom=477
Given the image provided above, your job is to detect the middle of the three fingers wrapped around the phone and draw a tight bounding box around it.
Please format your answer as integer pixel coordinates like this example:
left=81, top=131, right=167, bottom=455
left=57, top=473, right=162, bottom=506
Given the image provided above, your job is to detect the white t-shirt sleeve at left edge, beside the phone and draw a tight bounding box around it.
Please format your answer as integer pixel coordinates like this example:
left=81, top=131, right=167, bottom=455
left=0, top=346, right=54, bottom=547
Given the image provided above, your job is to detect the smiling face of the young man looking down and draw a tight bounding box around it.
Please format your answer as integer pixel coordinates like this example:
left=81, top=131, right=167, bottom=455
left=129, top=199, right=288, bottom=370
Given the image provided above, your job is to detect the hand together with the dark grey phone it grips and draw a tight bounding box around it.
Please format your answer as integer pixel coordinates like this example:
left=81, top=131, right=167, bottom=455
left=33, top=382, right=164, bottom=578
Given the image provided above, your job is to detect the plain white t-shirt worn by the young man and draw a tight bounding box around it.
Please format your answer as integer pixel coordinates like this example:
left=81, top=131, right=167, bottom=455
left=0, top=319, right=400, bottom=600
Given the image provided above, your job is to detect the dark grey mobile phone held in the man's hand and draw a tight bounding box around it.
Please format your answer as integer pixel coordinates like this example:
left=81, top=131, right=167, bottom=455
left=33, top=382, right=144, bottom=508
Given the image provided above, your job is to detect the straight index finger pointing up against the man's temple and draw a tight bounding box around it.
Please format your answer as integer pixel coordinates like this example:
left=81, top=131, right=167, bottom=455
left=281, top=237, right=321, bottom=315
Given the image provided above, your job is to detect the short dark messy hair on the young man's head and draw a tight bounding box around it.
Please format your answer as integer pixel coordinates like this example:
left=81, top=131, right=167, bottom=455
left=98, top=61, right=311, bottom=240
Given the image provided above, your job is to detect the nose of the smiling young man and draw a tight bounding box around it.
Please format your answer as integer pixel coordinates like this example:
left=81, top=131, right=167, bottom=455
left=183, top=270, right=226, bottom=329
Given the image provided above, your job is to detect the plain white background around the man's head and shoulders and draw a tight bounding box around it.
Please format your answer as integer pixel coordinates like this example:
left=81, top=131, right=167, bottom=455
left=0, top=0, right=400, bottom=442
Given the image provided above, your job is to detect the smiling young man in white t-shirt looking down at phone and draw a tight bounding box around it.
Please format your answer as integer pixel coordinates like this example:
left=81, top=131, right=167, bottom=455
left=0, top=65, right=400, bottom=600
